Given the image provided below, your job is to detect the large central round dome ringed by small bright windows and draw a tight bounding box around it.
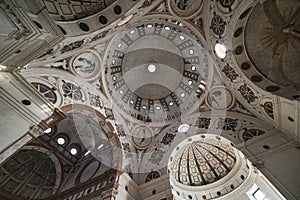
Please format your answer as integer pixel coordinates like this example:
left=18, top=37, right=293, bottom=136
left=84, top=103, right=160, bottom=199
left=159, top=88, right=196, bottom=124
left=102, top=15, right=212, bottom=125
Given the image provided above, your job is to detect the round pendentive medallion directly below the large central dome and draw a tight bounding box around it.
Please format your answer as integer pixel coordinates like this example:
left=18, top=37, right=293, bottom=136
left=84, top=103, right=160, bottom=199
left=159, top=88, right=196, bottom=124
left=132, top=125, right=154, bottom=149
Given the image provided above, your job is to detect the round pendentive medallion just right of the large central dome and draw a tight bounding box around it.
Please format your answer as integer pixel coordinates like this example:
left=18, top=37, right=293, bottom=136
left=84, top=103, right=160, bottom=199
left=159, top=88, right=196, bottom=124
left=206, top=86, right=234, bottom=110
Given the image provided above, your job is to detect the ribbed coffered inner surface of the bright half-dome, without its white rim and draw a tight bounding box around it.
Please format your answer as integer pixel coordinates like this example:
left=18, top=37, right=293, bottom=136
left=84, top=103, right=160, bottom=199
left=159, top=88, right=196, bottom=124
left=171, top=139, right=236, bottom=186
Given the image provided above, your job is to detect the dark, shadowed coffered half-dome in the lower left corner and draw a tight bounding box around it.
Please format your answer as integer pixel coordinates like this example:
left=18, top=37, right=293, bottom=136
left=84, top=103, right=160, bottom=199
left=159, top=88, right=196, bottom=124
left=0, top=147, right=60, bottom=200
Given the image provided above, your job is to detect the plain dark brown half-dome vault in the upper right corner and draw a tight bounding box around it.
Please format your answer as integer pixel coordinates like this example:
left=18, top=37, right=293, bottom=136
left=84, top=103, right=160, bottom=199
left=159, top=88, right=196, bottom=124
left=245, top=0, right=300, bottom=90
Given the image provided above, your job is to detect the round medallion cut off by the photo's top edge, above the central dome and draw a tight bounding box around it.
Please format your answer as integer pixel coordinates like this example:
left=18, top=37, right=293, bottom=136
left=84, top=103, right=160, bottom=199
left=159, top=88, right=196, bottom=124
left=168, top=0, right=203, bottom=19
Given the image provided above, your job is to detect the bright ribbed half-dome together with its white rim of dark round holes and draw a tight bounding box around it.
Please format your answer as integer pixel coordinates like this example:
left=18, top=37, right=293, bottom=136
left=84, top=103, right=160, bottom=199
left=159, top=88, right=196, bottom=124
left=168, top=134, right=249, bottom=199
